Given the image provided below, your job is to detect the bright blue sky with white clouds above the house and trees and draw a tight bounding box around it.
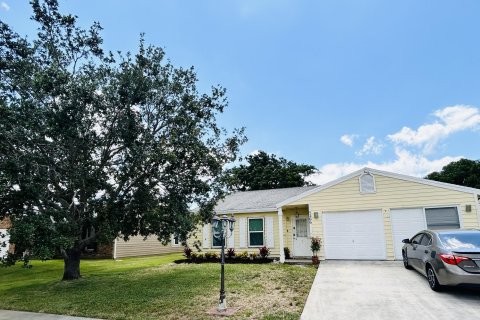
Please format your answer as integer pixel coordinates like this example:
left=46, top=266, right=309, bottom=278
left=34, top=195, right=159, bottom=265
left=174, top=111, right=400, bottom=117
left=0, top=0, right=480, bottom=183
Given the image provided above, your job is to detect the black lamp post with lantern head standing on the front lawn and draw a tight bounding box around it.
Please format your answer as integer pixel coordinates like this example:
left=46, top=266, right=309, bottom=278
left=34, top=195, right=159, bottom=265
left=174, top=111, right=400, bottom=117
left=212, top=214, right=235, bottom=311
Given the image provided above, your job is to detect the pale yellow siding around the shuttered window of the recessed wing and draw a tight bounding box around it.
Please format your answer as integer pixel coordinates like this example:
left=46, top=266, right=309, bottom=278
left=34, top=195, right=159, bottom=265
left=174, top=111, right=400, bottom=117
left=187, top=211, right=285, bottom=257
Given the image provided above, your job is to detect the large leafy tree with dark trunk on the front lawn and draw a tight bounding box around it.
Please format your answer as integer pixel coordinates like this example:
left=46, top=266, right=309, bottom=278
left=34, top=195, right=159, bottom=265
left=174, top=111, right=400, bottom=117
left=0, top=0, right=246, bottom=279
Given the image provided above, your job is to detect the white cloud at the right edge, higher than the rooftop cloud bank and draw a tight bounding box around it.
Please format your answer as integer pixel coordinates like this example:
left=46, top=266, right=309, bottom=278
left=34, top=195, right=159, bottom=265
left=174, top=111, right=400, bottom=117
left=387, top=105, right=480, bottom=154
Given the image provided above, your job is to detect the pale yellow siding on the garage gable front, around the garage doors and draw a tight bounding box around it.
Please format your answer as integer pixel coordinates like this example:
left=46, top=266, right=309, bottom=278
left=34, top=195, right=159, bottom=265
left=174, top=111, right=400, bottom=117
left=288, top=175, right=480, bottom=260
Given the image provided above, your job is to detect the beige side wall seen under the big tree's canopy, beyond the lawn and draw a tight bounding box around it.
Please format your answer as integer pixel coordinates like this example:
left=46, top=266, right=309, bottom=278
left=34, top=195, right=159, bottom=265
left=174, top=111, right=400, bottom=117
left=116, top=236, right=183, bottom=258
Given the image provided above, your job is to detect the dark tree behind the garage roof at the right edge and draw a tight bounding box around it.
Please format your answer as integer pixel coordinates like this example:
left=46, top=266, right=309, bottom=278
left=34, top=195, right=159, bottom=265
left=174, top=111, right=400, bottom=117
left=425, top=159, right=480, bottom=189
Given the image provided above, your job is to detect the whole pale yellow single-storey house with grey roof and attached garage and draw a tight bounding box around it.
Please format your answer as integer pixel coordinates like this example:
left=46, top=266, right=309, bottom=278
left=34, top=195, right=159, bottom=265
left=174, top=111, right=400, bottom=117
left=187, top=168, right=480, bottom=262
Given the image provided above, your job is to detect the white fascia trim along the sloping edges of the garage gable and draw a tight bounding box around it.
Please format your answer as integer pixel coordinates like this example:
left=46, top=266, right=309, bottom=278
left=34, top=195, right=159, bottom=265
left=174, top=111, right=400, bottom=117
left=276, top=167, right=480, bottom=208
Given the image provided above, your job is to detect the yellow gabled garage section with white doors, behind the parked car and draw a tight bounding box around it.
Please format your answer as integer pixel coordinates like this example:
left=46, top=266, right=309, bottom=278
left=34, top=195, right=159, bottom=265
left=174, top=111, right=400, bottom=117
left=277, top=168, right=480, bottom=260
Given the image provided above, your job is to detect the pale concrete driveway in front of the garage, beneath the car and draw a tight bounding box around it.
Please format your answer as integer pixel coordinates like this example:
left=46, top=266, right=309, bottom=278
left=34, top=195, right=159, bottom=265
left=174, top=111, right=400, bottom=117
left=302, top=261, right=480, bottom=320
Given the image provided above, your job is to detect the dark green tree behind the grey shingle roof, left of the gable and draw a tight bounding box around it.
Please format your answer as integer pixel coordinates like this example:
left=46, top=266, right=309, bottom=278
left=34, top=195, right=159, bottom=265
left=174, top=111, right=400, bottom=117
left=226, top=151, right=317, bottom=191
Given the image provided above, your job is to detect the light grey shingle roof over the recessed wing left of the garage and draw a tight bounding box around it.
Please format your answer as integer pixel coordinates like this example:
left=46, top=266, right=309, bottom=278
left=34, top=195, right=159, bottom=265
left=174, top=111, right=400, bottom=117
left=215, top=186, right=317, bottom=212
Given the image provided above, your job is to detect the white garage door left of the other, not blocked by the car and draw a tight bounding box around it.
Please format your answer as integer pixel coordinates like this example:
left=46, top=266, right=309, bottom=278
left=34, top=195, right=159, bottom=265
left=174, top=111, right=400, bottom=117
left=323, top=210, right=386, bottom=260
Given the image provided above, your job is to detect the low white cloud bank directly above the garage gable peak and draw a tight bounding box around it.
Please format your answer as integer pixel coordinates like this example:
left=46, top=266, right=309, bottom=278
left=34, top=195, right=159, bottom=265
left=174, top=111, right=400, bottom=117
left=308, top=148, right=462, bottom=185
